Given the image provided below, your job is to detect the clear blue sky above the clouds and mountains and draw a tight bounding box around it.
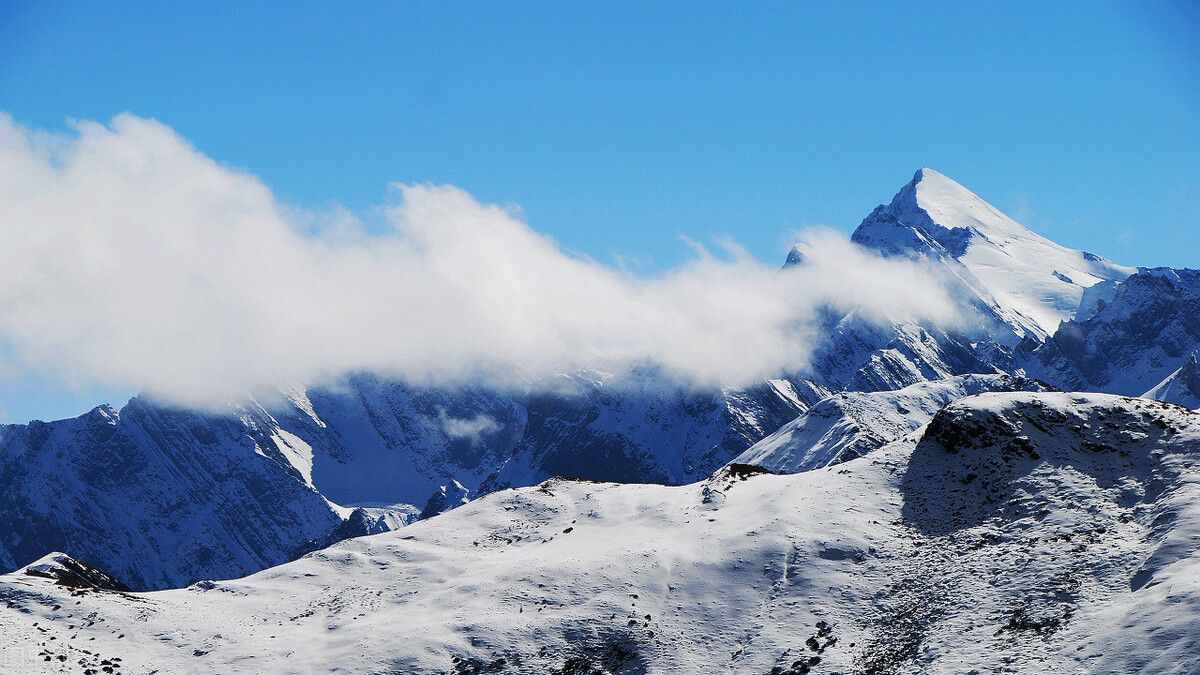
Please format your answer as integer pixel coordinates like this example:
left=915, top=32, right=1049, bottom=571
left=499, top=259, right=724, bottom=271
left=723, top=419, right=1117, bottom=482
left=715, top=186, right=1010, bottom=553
left=0, top=0, right=1200, bottom=420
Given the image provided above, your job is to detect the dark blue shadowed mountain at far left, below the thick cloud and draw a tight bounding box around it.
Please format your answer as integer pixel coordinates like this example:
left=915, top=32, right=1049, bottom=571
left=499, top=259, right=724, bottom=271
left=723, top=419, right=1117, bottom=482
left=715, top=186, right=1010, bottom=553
left=0, top=399, right=360, bottom=589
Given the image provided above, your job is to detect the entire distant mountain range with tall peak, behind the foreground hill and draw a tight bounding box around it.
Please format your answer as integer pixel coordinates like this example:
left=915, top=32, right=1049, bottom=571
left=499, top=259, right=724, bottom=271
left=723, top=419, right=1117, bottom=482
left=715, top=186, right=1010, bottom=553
left=0, top=163, right=1200, bottom=610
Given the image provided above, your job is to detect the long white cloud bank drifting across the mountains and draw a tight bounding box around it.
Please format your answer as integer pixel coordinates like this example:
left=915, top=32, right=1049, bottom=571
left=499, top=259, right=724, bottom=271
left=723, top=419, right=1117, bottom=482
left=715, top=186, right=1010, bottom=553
left=0, top=115, right=956, bottom=406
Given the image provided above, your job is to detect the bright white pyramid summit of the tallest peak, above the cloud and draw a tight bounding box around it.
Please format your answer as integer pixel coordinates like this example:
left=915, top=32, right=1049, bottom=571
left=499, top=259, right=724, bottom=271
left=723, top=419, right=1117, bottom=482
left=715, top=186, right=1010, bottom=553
left=853, top=168, right=1134, bottom=340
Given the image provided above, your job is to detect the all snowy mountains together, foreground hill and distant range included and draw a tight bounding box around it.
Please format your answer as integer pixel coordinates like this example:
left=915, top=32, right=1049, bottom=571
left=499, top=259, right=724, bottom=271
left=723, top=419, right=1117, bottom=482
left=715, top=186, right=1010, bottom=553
left=0, top=169, right=1200, bottom=673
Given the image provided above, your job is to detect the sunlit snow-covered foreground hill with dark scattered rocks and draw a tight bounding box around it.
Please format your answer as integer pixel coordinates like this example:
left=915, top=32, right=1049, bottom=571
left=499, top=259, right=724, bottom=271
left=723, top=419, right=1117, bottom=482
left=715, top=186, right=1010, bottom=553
left=0, top=393, right=1200, bottom=674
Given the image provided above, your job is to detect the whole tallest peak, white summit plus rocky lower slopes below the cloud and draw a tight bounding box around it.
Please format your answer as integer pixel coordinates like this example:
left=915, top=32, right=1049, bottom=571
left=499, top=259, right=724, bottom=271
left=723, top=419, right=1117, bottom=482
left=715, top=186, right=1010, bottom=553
left=785, top=168, right=1134, bottom=392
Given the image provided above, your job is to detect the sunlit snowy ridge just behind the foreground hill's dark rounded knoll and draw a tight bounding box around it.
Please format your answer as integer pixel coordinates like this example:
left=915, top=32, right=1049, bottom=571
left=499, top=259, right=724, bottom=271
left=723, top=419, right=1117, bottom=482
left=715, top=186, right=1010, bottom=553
left=733, top=375, right=1045, bottom=473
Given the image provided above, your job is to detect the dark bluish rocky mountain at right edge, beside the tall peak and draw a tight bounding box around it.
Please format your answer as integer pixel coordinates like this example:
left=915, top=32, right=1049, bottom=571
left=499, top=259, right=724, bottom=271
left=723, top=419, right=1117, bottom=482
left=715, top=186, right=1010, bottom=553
left=1019, top=268, right=1200, bottom=395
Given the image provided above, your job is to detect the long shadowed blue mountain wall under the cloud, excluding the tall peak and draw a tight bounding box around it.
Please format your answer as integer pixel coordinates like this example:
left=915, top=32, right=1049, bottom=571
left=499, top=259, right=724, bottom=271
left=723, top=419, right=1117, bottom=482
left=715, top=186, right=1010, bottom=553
left=0, top=375, right=827, bottom=590
